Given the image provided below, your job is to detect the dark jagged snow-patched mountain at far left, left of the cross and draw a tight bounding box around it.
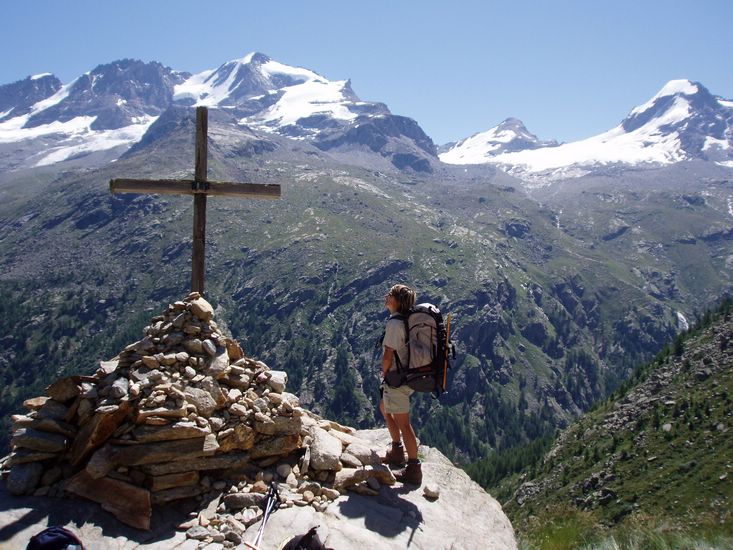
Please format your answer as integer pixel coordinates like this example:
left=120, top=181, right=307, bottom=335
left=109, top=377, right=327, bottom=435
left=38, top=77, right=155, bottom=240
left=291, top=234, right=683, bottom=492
left=0, top=59, right=189, bottom=168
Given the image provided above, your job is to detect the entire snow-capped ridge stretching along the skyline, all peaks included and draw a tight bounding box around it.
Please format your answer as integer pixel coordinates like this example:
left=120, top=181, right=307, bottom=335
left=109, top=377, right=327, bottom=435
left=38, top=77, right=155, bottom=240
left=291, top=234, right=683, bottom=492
left=0, top=56, right=733, bottom=181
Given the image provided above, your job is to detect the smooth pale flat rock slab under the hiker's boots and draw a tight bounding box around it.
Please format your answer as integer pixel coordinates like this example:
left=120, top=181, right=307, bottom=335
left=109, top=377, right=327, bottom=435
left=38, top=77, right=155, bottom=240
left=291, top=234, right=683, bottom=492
left=245, top=430, right=517, bottom=550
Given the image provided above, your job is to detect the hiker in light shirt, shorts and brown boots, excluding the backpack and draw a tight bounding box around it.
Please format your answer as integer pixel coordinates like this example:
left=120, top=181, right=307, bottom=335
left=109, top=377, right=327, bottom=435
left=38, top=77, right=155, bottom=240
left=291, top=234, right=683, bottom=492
left=379, top=284, right=422, bottom=485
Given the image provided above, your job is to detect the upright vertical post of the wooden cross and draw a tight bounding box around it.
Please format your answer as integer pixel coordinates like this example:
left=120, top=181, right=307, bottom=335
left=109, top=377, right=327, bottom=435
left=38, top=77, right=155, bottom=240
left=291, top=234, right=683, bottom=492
left=191, top=107, right=209, bottom=295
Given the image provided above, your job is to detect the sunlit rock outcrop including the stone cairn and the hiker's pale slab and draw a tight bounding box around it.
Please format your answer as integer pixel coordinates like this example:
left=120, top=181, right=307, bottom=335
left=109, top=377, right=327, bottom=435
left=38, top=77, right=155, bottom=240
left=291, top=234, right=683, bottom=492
left=0, top=293, right=516, bottom=549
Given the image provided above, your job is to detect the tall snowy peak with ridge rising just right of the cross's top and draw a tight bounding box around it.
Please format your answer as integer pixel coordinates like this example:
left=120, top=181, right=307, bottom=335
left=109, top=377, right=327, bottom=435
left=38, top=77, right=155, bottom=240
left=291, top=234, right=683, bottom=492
left=173, top=53, right=437, bottom=171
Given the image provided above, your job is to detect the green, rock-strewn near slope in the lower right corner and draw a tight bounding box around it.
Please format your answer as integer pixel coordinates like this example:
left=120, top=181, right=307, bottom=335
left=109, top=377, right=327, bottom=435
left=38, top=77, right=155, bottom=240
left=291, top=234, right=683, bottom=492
left=504, top=301, right=733, bottom=547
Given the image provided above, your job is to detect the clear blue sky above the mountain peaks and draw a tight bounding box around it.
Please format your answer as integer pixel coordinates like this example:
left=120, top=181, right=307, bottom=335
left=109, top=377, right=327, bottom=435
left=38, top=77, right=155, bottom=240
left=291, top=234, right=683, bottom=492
left=0, top=0, right=733, bottom=144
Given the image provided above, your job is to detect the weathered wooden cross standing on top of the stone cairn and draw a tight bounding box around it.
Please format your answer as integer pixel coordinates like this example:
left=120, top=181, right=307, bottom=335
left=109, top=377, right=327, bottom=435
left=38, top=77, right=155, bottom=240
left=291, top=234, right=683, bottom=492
left=109, top=107, right=280, bottom=295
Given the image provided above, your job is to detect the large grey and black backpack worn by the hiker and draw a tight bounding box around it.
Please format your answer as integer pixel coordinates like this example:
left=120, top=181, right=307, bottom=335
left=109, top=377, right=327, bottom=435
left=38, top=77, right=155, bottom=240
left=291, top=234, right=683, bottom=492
left=386, top=303, right=456, bottom=396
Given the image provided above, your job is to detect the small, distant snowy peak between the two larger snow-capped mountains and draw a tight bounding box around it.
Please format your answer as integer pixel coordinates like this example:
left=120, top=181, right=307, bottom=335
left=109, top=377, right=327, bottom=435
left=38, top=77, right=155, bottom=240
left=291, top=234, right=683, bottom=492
left=440, top=118, right=557, bottom=164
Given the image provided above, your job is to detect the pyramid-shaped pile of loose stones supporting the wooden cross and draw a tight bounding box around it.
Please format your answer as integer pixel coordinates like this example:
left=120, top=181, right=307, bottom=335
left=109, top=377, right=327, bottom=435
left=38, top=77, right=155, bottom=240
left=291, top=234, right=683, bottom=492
left=2, top=292, right=395, bottom=546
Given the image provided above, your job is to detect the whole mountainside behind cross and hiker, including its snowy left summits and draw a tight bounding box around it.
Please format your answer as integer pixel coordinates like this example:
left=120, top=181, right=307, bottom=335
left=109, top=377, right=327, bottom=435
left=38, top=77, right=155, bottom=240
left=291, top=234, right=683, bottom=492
left=0, top=54, right=733, bottom=476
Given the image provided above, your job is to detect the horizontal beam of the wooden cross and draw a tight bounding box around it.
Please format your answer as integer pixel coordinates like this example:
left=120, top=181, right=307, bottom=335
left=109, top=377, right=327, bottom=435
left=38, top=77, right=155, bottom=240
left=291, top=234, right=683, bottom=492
left=109, top=179, right=280, bottom=199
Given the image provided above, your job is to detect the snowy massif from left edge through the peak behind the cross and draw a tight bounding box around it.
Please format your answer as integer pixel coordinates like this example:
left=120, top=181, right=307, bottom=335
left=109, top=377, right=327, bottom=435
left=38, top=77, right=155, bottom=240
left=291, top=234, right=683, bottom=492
left=0, top=53, right=437, bottom=170
